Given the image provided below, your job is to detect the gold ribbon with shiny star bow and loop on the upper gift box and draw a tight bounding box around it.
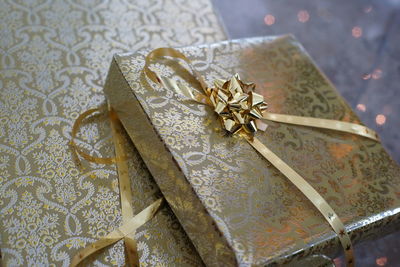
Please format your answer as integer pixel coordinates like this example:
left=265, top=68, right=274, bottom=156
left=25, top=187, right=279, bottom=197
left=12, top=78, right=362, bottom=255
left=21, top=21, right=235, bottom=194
left=143, top=48, right=379, bottom=266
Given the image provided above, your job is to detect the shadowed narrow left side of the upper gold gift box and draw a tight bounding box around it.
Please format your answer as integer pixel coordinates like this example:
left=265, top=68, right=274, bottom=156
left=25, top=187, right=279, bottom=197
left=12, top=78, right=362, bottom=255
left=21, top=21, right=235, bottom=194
left=104, top=55, right=236, bottom=266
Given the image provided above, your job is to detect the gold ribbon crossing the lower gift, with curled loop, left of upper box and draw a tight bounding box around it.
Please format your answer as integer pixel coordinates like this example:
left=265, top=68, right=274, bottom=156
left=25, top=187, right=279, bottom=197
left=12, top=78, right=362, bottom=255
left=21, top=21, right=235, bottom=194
left=70, top=107, right=163, bottom=267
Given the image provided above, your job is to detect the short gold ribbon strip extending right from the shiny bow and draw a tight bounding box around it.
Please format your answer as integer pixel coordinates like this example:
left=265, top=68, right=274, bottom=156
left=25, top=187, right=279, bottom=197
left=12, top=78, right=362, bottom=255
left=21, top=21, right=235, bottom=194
left=262, top=112, right=379, bottom=141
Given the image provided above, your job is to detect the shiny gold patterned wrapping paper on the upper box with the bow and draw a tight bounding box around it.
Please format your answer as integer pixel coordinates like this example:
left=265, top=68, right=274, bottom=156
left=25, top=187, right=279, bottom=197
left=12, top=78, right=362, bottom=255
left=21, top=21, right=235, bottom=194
left=105, top=36, right=400, bottom=266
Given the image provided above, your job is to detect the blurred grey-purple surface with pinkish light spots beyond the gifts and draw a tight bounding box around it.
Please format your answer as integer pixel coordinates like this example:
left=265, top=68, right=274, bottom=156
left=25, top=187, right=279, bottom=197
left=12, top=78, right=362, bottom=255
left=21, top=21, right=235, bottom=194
left=213, top=0, right=400, bottom=266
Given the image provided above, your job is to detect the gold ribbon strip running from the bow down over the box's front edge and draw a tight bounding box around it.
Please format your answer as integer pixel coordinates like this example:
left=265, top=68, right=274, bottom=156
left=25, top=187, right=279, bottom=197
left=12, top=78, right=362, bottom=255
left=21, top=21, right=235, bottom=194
left=247, top=138, right=354, bottom=267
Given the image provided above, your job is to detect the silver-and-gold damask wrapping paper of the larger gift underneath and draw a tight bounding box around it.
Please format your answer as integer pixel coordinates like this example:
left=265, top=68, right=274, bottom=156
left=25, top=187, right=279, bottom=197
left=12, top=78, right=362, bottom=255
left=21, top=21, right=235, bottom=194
left=0, top=0, right=225, bottom=266
